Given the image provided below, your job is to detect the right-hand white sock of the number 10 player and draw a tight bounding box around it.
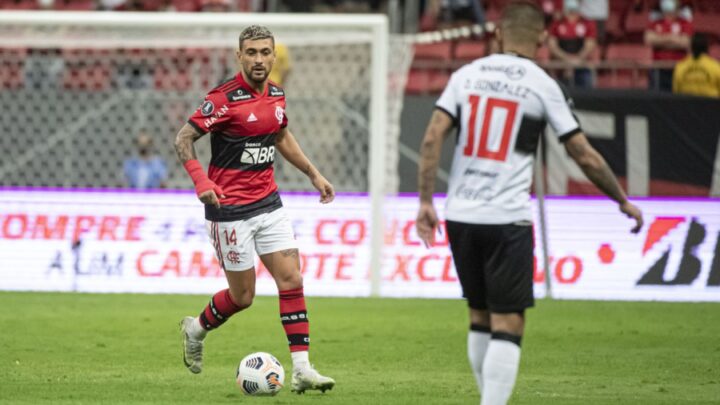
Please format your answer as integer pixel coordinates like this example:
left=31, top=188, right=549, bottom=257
left=480, top=339, right=520, bottom=405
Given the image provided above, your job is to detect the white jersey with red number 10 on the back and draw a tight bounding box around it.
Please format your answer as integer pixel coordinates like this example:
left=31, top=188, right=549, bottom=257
left=436, top=54, right=579, bottom=224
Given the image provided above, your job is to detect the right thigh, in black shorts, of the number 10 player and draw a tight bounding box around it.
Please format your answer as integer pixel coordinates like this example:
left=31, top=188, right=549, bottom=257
left=485, top=224, right=535, bottom=313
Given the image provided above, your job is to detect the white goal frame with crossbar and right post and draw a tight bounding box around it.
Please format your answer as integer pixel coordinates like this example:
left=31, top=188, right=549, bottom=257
left=0, top=11, right=389, bottom=296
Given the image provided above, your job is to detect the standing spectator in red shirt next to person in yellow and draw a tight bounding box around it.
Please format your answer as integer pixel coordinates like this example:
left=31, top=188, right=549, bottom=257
left=645, top=0, right=693, bottom=91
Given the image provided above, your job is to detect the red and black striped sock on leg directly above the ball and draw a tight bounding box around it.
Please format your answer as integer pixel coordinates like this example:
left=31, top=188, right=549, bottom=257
left=280, top=287, right=310, bottom=352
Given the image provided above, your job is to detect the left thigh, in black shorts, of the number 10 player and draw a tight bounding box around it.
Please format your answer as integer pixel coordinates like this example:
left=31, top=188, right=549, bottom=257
left=445, top=221, right=487, bottom=310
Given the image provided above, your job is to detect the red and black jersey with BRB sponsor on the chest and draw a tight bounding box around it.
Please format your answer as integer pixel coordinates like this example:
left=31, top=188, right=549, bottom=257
left=188, top=73, right=288, bottom=221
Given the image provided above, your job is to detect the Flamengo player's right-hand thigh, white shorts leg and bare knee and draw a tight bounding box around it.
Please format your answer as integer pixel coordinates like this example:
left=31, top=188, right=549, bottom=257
left=255, top=208, right=302, bottom=290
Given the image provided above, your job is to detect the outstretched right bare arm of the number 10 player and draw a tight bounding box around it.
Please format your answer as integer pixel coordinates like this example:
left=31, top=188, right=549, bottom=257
left=565, top=133, right=643, bottom=233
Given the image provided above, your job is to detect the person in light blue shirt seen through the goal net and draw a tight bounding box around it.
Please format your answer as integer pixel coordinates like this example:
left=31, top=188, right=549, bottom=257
left=123, top=132, right=167, bottom=190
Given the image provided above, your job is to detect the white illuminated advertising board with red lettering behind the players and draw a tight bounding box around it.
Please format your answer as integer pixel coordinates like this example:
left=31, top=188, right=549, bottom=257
left=0, top=188, right=720, bottom=301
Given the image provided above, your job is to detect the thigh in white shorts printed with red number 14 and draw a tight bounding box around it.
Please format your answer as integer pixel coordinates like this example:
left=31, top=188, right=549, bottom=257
left=206, top=218, right=255, bottom=271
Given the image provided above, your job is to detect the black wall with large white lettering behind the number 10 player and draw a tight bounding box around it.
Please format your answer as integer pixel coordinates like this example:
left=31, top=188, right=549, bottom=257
left=399, top=90, right=720, bottom=197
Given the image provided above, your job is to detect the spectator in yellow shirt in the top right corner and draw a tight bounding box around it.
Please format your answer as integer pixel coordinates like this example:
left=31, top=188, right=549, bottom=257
left=673, top=34, right=720, bottom=98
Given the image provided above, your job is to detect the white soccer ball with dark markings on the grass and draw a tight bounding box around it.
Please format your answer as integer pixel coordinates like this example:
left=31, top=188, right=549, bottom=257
left=237, top=352, right=285, bottom=395
